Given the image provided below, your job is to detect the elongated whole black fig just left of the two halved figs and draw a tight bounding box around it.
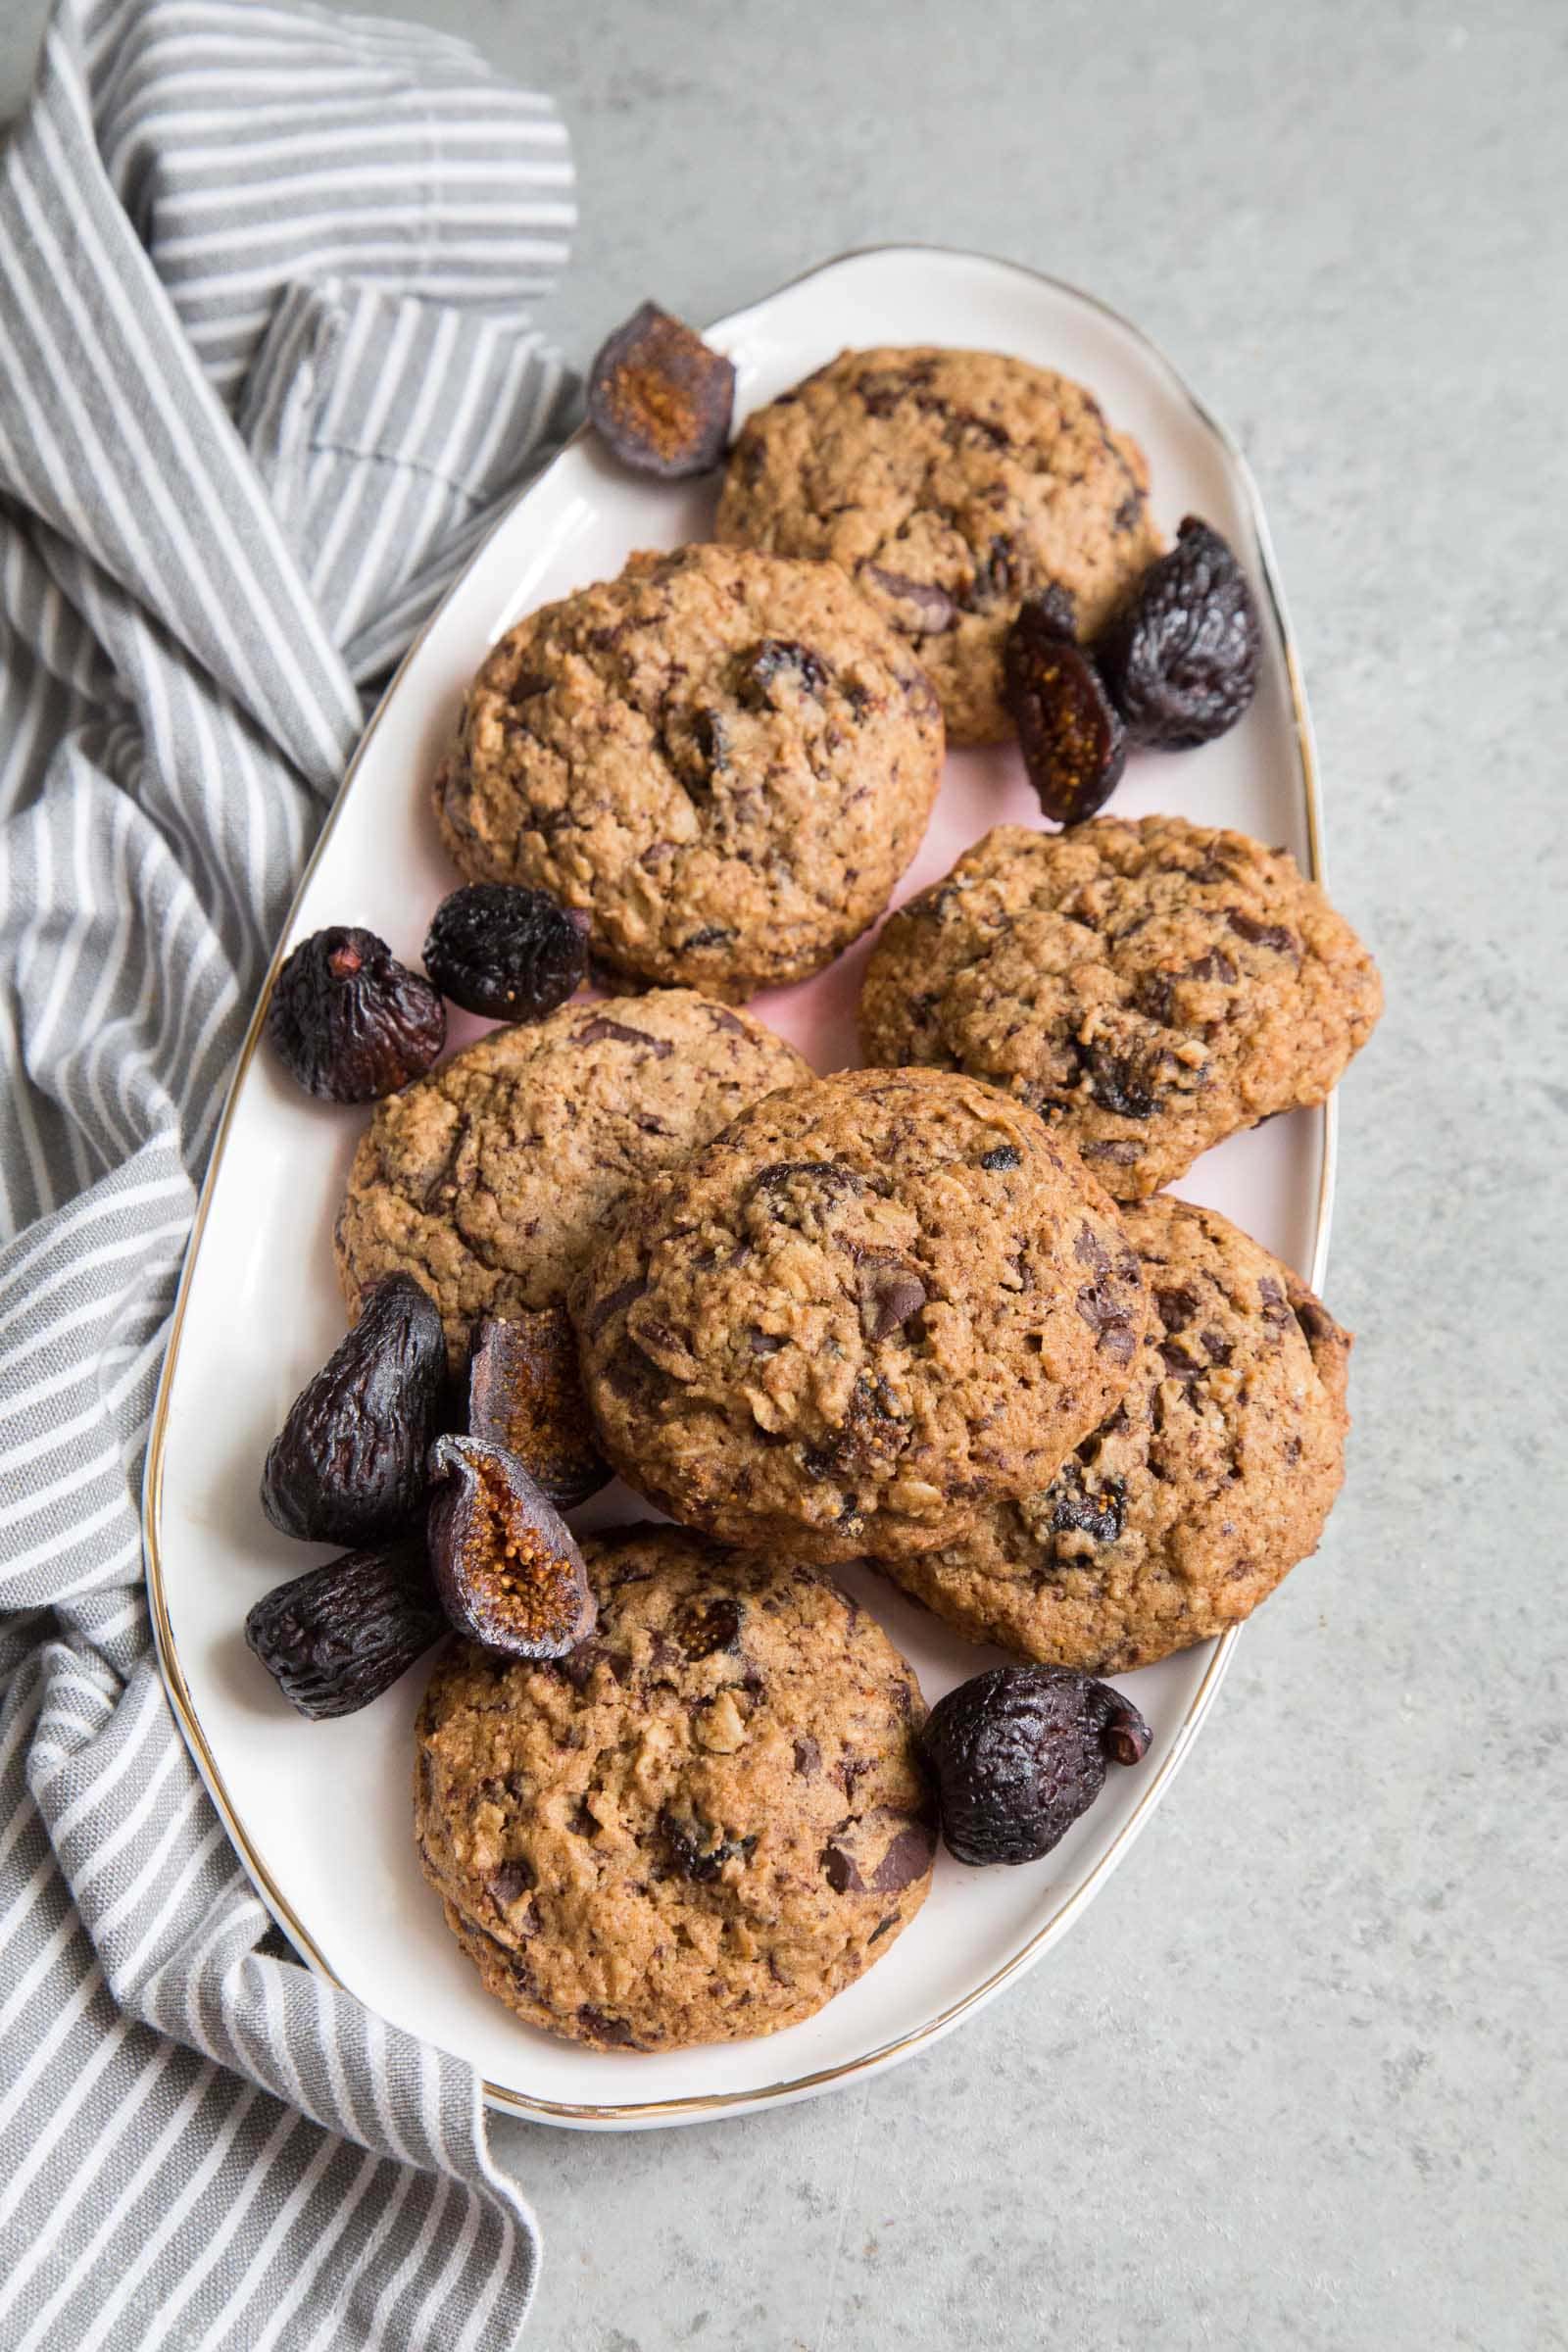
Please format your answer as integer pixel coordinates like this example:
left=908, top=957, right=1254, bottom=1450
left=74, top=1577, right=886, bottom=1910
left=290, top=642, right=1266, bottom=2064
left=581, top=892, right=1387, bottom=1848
left=261, top=1275, right=447, bottom=1543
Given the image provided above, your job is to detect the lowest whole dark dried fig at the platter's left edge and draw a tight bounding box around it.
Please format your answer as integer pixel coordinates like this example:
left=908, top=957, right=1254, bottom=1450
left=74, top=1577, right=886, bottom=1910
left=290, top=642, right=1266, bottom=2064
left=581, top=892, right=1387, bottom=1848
left=244, top=1541, right=447, bottom=1719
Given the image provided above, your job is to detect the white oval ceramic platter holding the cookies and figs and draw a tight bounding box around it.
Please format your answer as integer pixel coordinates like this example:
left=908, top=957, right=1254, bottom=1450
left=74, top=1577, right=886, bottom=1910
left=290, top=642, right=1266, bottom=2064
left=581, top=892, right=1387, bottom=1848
left=146, top=247, right=1333, bottom=2129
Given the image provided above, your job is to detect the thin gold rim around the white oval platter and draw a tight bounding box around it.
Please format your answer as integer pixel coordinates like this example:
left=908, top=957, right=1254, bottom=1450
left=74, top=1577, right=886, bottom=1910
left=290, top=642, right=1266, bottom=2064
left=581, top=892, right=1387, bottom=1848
left=143, top=242, right=1338, bottom=2127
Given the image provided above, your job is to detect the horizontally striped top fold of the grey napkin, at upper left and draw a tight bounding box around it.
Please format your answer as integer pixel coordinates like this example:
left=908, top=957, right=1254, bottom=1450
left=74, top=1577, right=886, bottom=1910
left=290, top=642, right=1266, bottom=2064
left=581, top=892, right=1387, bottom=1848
left=94, top=0, right=576, bottom=412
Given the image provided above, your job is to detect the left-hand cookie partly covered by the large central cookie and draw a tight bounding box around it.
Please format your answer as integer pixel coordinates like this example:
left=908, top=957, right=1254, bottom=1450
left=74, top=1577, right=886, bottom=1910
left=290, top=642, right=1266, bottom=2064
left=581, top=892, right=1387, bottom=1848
left=336, top=988, right=811, bottom=1364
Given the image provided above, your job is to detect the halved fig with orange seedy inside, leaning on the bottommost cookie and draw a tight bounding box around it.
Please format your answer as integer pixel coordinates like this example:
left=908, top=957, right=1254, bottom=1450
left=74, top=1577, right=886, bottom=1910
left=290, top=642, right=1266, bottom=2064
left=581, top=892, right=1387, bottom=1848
left=425, top=1437, right=597, bottom=1658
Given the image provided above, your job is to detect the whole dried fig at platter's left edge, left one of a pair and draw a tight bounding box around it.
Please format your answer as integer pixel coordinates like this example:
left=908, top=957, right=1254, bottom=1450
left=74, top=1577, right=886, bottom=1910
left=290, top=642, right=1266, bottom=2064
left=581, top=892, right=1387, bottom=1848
left=266, top=924, right=447, bottom=1103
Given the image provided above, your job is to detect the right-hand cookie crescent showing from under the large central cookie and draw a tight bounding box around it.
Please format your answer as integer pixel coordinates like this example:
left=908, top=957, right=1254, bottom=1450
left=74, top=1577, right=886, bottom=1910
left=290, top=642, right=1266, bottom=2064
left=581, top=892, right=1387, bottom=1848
left=889, top=1195, right=1349, bottom=1675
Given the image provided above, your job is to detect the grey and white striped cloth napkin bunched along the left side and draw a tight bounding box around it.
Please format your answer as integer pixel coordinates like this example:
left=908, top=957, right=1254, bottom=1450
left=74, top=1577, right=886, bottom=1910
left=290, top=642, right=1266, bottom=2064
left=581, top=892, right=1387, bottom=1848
left=0, top=0, right=571, bottom=2352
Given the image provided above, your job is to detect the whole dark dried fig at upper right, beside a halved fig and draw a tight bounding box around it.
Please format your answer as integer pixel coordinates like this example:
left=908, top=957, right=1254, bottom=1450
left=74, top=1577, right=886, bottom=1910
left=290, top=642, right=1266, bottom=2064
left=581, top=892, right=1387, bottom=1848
left=1096, top=515, right=1262, bottom=751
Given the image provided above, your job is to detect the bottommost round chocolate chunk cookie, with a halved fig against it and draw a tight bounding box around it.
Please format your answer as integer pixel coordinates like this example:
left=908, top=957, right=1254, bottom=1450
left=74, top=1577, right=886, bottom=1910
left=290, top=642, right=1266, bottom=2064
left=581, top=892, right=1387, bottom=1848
left=414, top=1527, right=936, bottom=2051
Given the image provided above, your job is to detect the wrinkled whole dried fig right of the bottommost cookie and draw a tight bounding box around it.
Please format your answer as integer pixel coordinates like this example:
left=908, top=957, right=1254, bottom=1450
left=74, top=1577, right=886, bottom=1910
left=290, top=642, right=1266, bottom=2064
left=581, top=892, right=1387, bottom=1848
left=921, top=1665, right=1150, bottom=1863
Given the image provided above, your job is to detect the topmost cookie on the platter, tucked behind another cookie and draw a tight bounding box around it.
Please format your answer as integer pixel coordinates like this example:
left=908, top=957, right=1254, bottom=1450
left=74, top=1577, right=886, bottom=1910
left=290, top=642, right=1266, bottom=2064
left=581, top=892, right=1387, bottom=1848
left=717, top=351, right=1159, bottom=743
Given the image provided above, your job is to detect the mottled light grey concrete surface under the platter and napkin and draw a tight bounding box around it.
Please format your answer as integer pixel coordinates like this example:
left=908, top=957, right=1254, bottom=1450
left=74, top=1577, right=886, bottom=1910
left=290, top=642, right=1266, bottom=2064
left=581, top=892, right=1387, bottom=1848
left=0, top=0, right=1568, bottom=2352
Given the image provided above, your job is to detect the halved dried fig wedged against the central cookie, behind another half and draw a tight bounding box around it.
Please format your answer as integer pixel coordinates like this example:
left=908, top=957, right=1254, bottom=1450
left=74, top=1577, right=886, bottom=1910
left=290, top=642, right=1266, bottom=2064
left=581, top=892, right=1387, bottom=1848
left=467, top=1305, right=609, bottom=1510
